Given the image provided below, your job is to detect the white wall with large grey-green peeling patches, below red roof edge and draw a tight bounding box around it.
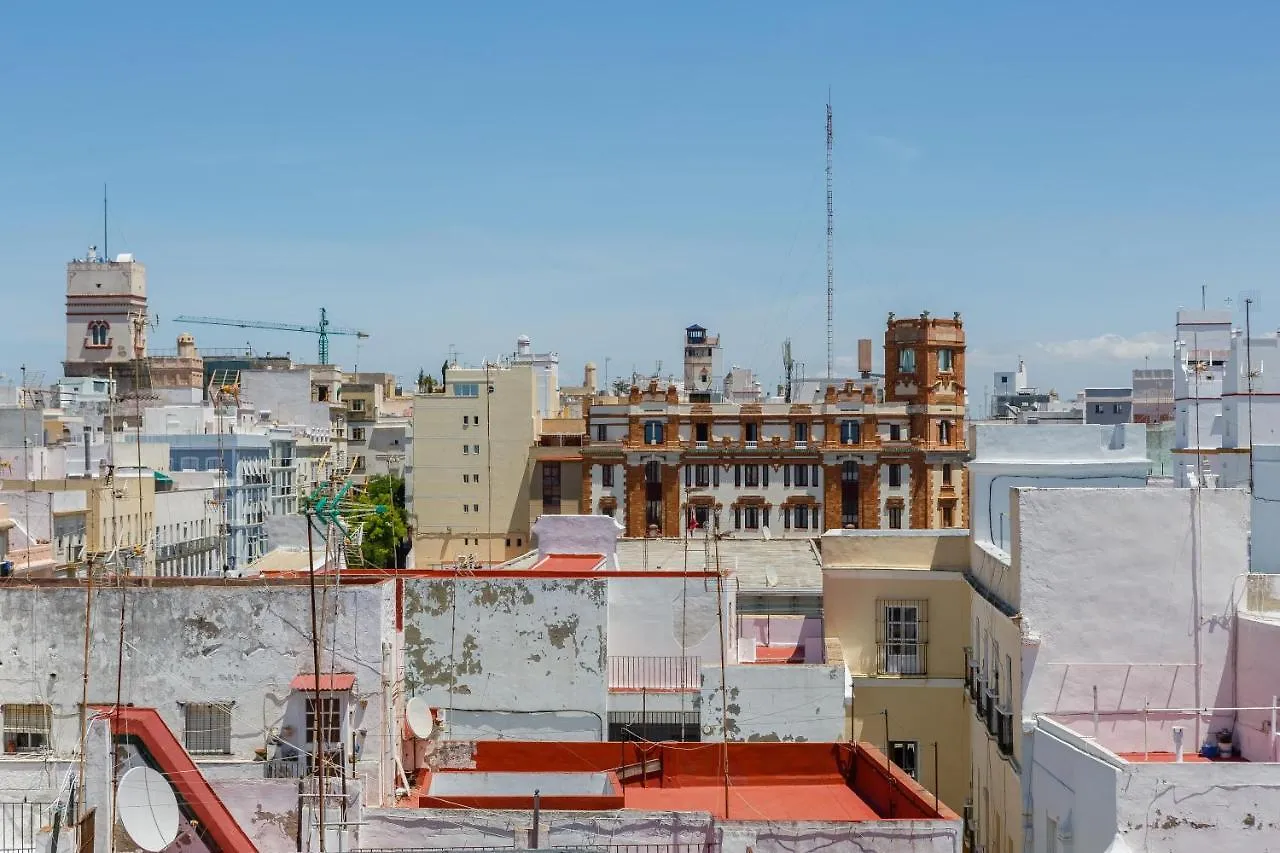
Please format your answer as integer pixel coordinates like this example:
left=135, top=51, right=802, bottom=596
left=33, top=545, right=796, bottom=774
left=404, top=576, right=608, bottom=739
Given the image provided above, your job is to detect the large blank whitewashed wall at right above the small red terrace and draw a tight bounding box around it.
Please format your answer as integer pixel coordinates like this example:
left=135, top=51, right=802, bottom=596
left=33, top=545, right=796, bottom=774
left=1014, top=488, right=1249, bottom=752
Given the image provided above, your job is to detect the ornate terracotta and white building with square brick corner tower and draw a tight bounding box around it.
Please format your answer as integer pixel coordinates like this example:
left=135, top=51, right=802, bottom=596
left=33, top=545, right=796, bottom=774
left=581, top=314, right=968, bottom=537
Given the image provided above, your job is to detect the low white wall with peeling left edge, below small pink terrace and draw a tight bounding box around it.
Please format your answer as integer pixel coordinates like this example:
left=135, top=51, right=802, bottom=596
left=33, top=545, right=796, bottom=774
left=700, top=663, right=845, bottom=743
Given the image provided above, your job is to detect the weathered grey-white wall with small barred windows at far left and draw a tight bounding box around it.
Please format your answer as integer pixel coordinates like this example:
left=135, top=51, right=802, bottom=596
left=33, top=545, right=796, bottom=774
left=0, top=583, right=398, bottom=794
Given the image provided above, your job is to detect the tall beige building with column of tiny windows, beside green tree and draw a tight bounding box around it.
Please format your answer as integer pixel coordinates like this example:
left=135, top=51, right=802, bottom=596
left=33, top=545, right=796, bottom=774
left=410, top=362, right=541, bottom=567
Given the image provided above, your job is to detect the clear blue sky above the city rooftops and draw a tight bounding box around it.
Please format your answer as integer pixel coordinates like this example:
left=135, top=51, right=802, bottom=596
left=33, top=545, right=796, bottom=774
left=0, top=0, right=1280, bottom=393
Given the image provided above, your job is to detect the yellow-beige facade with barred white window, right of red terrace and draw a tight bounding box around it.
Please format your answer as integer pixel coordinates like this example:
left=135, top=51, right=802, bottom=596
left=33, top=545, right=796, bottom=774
left=820, top=530, right=970, bottom=811
